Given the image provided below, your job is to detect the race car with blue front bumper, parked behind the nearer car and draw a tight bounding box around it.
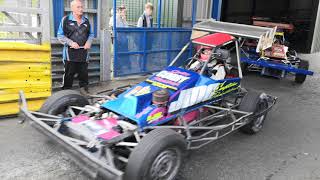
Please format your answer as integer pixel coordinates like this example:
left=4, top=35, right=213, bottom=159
left=241, top=19, right=313, bottom=84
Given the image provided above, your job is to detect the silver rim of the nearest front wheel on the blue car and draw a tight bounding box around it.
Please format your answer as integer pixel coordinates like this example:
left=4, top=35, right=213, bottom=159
left=150, top=148, right=181, bottom=180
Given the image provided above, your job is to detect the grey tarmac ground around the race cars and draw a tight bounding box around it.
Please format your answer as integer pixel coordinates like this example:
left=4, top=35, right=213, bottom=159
left=0, top=54, right=320, bottom=180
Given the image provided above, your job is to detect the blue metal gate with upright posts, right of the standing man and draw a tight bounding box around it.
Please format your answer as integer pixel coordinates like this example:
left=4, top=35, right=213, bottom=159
left=113, top=0, right=197, bottom=77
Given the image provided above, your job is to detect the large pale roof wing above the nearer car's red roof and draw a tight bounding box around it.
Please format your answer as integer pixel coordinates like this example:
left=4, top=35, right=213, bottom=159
left=191, top=19, right=277, bottom=52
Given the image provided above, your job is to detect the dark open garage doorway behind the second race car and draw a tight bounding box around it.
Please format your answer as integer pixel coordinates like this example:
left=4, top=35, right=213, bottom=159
left=221, top=0, right=319, bottom=52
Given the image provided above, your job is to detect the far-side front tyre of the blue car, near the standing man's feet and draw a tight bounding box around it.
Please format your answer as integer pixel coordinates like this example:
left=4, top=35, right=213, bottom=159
left=39, top=90, right=89, bottom=115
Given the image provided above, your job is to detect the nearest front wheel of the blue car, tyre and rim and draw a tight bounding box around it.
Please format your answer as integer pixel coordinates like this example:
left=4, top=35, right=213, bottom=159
left=124, top=129, right=186, bottom=180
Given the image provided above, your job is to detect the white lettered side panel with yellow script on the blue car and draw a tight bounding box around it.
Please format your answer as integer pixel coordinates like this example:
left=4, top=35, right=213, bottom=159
left=169, top=82, right=239, bottom=113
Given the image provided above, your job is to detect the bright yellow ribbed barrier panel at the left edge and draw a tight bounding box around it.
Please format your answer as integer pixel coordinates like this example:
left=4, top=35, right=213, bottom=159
left=0, top=42, right=51, bottom=116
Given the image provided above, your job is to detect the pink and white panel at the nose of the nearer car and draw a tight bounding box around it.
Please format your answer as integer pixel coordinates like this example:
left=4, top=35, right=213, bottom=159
left=72, top=115, right=120, bottom=140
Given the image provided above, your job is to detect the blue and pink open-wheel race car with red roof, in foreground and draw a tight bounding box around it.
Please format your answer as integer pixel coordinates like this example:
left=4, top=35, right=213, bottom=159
left=20, top=21, right=276, bottom=180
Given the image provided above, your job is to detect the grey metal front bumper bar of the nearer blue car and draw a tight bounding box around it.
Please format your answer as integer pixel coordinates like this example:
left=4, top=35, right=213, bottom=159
left=19, top=91, right=124, bottom=180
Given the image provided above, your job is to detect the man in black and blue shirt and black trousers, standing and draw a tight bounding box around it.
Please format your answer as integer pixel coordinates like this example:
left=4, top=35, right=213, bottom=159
left=58, top=0, right=94, bottom=94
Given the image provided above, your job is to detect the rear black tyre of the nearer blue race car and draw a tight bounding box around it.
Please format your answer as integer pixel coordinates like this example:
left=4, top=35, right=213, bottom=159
left=239, top=91, right=268, bottom=134
